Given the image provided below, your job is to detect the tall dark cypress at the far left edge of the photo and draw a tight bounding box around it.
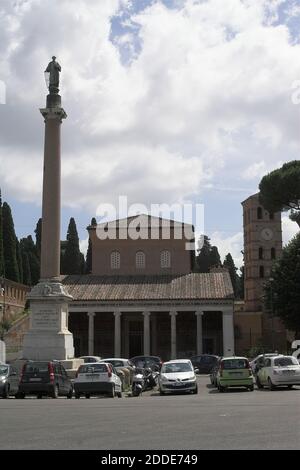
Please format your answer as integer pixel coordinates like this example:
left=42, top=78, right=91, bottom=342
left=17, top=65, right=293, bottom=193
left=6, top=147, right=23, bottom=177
left=2, top=202, right=20, bottom=282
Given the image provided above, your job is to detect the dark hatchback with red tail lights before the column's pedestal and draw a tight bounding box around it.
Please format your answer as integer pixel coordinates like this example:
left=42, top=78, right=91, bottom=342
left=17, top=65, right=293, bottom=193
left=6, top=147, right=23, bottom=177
left=17, top=361, right=73, bottom=398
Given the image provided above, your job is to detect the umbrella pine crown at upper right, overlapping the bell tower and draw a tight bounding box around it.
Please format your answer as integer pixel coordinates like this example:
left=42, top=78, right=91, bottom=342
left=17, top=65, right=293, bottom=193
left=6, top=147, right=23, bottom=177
left=259, top=160, right=300, bottom=227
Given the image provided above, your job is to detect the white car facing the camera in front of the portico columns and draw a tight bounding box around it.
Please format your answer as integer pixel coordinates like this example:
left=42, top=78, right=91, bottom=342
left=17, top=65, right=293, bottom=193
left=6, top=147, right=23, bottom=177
left=158, top=359, right=198, bottom=395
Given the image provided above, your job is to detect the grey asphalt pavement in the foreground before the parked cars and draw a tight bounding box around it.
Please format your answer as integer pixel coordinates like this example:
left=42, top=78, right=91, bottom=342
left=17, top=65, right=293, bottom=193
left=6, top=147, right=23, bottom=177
left=0, top=376, right=300, bottom=450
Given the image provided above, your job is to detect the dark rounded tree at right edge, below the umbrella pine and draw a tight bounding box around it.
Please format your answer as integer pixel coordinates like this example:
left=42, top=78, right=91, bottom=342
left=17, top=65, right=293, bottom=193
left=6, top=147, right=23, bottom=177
left=265, top=233, right=300, bottom=339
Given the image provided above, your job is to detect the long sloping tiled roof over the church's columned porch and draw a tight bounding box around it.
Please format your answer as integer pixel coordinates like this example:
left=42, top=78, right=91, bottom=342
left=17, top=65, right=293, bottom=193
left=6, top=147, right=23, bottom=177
left=62, top=272, right=234, bottom=302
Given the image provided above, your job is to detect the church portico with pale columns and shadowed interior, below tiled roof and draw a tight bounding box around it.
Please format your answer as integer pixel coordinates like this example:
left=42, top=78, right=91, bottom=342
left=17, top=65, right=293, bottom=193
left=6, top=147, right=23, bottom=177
left=70, top=302, right=234, bottom=360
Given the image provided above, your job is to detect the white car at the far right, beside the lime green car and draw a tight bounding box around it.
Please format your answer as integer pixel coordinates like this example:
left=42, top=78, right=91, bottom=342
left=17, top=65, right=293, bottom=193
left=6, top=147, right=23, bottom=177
left=256, top=355, right=300, bottom=390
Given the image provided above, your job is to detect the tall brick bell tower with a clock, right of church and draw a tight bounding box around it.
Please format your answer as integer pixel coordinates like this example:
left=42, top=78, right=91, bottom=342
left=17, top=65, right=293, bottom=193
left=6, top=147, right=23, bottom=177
left=242, top=193, right=282, bottom=312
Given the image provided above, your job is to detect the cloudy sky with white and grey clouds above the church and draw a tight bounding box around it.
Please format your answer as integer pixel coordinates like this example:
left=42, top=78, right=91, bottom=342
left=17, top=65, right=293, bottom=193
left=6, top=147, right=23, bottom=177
left=0, top=0, right=300, bottom=264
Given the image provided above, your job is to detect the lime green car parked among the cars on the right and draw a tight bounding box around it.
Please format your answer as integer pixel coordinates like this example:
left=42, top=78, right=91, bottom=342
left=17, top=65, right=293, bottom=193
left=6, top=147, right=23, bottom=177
left=217, top=356, right=254, bottom=392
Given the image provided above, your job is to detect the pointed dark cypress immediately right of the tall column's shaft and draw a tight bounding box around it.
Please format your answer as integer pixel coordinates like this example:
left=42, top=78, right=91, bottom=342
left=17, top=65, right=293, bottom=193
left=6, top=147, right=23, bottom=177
left=62, top=217, right=82, bottom=274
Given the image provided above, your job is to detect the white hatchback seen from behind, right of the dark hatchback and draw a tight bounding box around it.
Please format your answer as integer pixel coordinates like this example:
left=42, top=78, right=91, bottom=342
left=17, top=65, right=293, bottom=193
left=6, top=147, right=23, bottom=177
left=74, top=362, right=122, bottom=398
